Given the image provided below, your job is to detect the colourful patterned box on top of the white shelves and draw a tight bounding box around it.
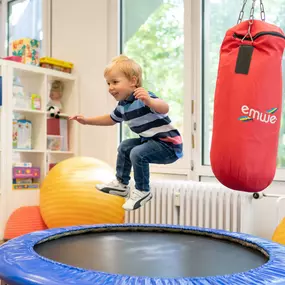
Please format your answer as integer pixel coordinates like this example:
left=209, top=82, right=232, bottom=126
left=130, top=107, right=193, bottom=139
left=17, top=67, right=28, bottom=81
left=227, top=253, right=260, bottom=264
left=12, top=38, right=40, bottom=65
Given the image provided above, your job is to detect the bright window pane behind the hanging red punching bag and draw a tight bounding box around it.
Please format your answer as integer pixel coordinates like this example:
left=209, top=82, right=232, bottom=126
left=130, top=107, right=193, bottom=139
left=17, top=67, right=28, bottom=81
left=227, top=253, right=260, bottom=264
left=202, top=0, right=285, bottom=167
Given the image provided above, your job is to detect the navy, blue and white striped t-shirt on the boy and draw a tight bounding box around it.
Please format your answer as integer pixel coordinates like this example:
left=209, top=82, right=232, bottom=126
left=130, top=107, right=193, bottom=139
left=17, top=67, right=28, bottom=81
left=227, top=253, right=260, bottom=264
left=108, top=92, right=183, bottom=158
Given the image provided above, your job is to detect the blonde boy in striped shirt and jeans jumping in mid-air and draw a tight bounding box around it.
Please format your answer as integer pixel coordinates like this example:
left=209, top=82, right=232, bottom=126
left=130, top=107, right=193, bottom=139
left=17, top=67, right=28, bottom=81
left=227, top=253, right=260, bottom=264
left=70, top=55, right=182, bottom=211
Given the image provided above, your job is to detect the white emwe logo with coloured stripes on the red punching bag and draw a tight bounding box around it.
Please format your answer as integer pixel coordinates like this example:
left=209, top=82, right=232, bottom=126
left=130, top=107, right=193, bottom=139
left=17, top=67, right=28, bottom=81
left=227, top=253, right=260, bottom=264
left=239, top=105, right=278, bottom=124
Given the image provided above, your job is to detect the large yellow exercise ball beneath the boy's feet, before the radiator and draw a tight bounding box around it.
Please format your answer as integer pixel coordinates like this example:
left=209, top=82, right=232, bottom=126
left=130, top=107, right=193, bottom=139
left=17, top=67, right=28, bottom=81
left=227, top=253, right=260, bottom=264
left=40, top=157, right=124, bottom=228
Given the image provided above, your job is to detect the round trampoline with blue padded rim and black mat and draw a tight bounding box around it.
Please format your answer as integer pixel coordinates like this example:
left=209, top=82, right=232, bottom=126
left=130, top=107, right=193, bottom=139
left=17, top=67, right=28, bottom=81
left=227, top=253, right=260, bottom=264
left=0, top=224, right=285, bottom=285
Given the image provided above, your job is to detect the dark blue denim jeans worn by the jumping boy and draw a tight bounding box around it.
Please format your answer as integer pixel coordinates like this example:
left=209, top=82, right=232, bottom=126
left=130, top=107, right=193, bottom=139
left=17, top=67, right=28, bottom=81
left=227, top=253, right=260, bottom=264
left=116, top=138, right=178, bottom=191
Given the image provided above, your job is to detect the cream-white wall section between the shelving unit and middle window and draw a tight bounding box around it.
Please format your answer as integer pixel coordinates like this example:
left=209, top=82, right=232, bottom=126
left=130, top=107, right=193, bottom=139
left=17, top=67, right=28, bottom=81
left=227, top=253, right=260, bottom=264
left=51, top=0, right=117, bottom=164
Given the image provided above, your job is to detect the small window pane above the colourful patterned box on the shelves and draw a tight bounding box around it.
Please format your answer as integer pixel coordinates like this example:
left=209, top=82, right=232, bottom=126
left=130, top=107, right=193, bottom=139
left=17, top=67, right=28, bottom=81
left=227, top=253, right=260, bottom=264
left=8, top=0, right=43, bottom=55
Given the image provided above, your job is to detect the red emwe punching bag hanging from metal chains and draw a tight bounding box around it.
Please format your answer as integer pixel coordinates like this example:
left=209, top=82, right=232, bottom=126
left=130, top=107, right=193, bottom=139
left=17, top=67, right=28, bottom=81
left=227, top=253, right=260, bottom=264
left=210, top=1, right=285, bottom=192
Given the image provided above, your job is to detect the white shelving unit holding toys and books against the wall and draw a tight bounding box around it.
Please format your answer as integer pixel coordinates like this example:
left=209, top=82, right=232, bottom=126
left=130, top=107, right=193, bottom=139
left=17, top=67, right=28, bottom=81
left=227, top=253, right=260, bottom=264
left=0, top=60, right=79, bottom=239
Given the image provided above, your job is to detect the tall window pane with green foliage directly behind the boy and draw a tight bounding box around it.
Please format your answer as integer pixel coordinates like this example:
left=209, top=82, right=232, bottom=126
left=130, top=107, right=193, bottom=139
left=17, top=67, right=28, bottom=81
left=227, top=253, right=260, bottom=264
left=121, top=0, right=184, bottom=139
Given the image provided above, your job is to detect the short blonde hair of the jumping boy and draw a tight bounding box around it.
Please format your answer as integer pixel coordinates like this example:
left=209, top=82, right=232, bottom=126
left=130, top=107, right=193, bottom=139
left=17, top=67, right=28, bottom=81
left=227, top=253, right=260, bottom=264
left=104, top=54, right=142, bottom=87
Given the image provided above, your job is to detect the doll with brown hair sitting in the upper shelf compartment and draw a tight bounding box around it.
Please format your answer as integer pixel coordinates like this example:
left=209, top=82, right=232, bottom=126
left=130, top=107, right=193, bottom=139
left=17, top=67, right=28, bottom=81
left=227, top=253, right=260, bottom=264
left=47, top=80, right=63, bottom=119
